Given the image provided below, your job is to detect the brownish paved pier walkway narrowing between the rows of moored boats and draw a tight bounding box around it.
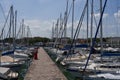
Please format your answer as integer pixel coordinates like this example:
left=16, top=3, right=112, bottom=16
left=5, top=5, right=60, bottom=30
left=24, top=48, right=67, bottom=80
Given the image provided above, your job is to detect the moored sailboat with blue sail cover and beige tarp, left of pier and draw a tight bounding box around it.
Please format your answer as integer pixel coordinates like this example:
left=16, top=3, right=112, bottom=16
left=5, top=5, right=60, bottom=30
left=0, top=6, right=28, bottom=68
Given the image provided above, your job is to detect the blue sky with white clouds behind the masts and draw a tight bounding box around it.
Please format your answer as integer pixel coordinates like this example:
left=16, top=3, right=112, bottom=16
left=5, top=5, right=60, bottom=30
left=0, top=0, right=120, bottom=38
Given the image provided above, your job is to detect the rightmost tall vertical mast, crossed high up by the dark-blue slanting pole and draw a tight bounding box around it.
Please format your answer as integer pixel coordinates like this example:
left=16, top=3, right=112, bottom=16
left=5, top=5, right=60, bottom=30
left=100, top=0, right=103, bottom=61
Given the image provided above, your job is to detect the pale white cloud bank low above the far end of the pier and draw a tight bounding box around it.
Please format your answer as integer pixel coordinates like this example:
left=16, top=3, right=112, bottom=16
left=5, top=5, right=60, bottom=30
left=25, top=19, right=54, bottom=37
